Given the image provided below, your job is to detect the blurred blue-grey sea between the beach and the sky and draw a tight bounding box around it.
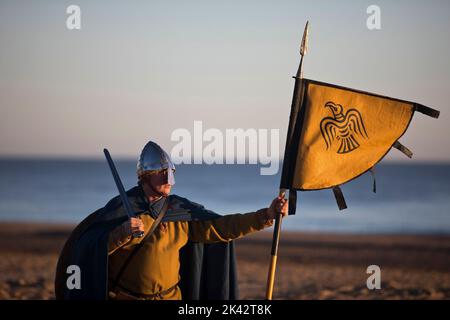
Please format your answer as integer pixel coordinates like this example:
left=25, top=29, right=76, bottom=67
left=0, top=158, right=450, bottom=234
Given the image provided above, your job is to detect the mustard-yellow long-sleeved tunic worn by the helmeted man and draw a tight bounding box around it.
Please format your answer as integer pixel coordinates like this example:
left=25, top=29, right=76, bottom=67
left=108, top=209, right=273, bottom=299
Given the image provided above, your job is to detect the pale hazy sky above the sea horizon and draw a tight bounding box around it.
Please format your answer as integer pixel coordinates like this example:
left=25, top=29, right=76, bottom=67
left=0, top=0, right=450, bottom=161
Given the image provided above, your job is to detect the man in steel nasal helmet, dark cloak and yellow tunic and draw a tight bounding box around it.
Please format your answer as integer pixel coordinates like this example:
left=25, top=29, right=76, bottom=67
left=55, top=141, right=288, bottom=300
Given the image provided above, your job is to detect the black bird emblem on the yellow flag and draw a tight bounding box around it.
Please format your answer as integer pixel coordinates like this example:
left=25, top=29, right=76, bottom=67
left=320, top=101, right=368, bottom=154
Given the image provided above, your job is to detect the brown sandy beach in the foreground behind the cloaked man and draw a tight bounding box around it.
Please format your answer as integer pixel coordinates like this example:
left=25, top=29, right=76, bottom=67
left=0, top=223, right=450, bottom=299
